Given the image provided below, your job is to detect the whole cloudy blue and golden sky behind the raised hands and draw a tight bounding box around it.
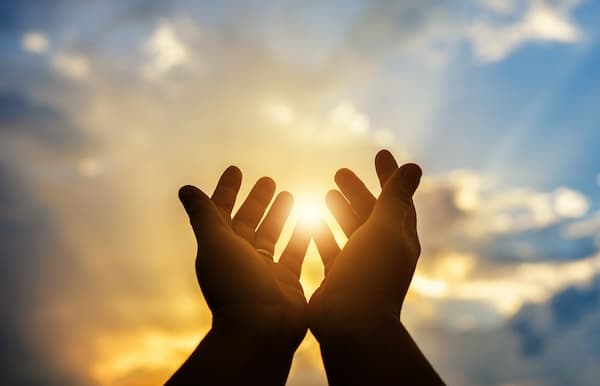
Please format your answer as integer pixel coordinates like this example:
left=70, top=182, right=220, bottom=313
left=0, top=0, right=600, bottom=386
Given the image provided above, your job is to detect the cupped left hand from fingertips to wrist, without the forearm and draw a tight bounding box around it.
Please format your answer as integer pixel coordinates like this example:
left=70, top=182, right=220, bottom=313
left=179, top=166, right=310, bottom=355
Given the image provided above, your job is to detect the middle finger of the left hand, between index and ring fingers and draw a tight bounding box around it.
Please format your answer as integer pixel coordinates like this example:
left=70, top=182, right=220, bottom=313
left=231, top=177, right=275, bottom=242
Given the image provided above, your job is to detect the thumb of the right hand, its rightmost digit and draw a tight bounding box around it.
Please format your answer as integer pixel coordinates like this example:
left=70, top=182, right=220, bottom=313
left=375, top=164, right=423, bottom=219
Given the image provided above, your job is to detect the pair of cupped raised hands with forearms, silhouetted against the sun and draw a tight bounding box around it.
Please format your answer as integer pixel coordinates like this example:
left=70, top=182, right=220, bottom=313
left=168, top=151, right=442, bottom=385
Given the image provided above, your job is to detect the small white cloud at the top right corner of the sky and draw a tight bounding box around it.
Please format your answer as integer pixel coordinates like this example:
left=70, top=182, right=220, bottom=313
left=468, top=0, right=581, bottom=61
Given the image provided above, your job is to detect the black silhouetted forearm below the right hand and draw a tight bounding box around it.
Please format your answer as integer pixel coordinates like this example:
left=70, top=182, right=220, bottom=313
left=320, top=321, right=444, bottom=386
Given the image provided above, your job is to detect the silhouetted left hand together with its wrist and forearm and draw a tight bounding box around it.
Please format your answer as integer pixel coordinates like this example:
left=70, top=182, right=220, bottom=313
left=170, top=166, right=310, bottom=385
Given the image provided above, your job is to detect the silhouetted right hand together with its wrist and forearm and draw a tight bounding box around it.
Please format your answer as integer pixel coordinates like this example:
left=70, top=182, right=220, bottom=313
left=309, top=151, right=441, bottom=385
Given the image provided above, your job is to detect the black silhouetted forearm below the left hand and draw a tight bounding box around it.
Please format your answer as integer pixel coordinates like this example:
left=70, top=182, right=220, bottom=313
left=166, top=330, right=294, bottom=386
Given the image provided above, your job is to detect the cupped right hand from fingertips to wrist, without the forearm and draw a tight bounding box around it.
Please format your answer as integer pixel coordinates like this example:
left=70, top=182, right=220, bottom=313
left=309, top=151, right=421, bottom=341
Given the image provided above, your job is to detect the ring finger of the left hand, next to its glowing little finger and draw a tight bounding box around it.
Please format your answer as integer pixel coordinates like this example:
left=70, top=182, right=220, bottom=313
left=254, top=192, right=294, bottom=254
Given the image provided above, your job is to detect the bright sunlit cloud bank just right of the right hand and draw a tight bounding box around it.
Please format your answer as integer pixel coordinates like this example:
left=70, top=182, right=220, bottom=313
left=411, top=170, right=600, bottom=326
